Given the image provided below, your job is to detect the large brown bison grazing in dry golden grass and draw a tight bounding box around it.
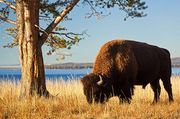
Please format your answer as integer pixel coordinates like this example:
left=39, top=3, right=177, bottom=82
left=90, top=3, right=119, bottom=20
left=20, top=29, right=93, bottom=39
left=81, top=40, right=173, bottom=103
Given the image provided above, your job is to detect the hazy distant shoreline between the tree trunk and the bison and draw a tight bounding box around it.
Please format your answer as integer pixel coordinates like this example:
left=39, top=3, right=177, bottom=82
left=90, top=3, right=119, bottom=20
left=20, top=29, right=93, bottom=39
left=45, top=63, right=93, bottom=69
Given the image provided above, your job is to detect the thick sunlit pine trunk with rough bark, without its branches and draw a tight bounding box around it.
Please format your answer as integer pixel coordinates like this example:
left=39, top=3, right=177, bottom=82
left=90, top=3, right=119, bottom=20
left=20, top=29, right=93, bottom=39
left=16, top=0, right=49, bottom=97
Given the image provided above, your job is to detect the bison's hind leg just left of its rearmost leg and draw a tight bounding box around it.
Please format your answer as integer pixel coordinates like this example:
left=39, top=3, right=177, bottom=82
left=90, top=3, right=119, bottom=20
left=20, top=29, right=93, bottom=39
left=150, top=79, right=161, bottom=103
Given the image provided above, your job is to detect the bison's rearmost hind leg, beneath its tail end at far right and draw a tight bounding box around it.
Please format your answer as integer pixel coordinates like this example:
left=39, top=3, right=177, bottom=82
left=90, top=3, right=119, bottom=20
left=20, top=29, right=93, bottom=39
left=162, top=78, right=173, bottom=102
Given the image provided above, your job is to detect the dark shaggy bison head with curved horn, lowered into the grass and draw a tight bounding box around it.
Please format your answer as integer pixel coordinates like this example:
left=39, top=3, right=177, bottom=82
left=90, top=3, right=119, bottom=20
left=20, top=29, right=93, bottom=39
left=81, top=73, right=109, bottom=104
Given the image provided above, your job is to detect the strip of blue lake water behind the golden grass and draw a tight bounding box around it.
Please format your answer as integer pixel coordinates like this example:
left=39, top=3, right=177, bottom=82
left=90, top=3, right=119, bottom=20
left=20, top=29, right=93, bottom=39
left=0, top=68, right=180, bottom=80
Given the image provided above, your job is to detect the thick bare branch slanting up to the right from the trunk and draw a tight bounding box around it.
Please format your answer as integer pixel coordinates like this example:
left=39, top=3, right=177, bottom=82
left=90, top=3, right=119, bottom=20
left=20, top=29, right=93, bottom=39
left=40, top=0, right=80, bottom=45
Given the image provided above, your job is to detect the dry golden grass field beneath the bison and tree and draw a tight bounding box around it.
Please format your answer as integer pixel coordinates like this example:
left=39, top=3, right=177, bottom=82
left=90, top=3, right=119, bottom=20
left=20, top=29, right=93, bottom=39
left=0, top=76, right=180, bottom=119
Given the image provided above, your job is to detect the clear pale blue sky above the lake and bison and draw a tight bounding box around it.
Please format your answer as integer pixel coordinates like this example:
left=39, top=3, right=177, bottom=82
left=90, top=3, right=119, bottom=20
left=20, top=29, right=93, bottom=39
left=0, top=0, right=180, bottom=65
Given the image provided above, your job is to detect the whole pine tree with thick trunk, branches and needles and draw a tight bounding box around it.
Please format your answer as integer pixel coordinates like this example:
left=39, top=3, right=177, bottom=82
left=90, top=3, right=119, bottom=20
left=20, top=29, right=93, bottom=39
left=0, top=0, right=147, bottom=97
